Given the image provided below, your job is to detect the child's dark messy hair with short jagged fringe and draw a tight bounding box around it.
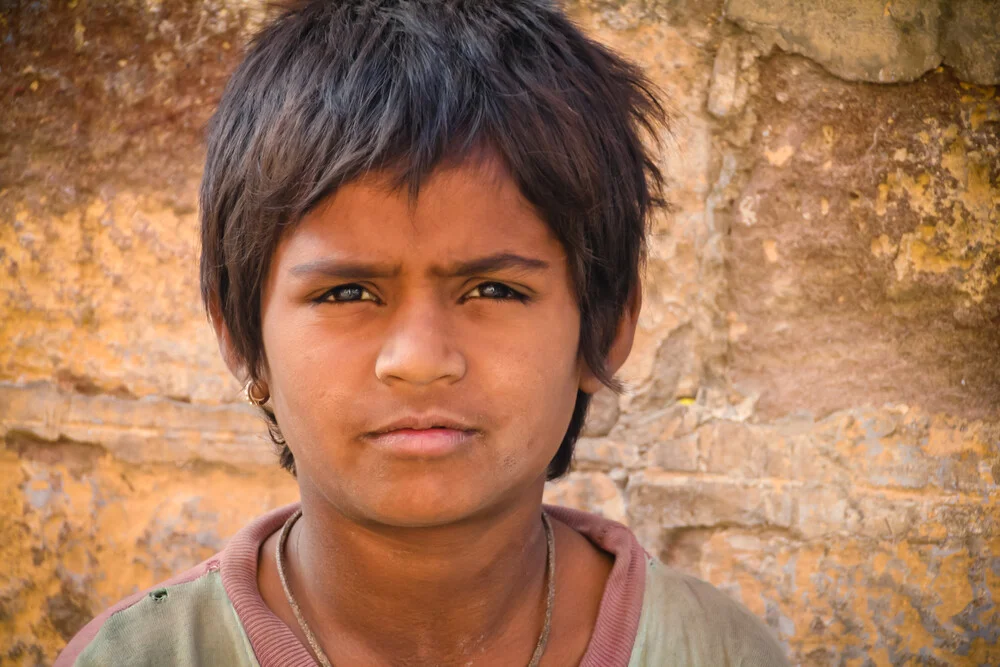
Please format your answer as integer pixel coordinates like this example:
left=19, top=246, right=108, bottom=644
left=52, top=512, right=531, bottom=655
left=201, top=0, right=667, bottom=479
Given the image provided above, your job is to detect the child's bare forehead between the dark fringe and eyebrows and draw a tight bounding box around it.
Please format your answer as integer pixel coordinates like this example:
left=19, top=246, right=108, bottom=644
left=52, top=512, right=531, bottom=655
left=274, top=160, right=564, bottom=267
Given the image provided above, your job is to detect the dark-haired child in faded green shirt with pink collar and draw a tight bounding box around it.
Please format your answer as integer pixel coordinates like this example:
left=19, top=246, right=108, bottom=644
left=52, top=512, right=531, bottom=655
left=60, top=0, right=785, bottom=667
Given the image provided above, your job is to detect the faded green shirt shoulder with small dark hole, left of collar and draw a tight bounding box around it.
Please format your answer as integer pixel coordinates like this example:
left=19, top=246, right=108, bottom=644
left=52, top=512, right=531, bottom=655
left=56, top=558, right=256, bottom=667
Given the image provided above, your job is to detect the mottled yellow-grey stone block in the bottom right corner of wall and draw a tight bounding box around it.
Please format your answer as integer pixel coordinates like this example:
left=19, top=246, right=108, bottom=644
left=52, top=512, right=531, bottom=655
left=699, top=529, right=1000, bottom=666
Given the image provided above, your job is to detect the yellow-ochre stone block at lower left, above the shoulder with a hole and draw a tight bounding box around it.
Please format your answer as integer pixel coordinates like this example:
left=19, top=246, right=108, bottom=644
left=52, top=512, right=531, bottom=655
left=0, top=446, right=298, bottom=664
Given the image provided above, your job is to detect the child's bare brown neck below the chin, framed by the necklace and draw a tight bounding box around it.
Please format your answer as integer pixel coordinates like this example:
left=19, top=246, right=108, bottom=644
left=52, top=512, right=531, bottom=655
left=285, top=484, right=546, bottom=664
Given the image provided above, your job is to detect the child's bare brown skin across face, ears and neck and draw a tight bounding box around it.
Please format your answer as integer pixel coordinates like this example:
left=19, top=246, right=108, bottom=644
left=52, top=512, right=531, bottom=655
left=213, top=159, right=640, bottom=666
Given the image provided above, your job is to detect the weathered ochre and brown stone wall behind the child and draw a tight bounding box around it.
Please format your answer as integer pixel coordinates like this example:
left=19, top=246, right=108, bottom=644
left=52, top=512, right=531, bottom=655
left=0, top=0, right=1000, bottom=666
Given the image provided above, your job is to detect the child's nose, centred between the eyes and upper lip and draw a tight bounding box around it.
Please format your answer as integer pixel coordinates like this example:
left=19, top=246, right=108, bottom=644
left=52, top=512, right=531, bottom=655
left=375, top=300, right=466, bottom=385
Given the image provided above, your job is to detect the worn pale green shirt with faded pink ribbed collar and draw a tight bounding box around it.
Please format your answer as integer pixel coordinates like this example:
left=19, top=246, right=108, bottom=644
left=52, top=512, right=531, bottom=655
left=56, top=505, right=787, bottom=667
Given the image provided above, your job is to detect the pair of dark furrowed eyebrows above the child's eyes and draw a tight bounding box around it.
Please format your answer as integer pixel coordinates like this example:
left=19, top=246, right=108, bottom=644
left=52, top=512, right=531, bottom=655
left=289, top=252, right=549, bottom=279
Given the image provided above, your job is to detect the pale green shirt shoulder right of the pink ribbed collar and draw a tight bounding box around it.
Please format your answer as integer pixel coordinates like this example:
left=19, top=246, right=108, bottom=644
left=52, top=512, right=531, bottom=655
left=629, top=557, right=788, bottom=667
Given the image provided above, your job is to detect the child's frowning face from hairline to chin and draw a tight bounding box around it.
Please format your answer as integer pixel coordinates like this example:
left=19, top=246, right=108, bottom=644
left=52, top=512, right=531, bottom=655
left=262, top=161, right=599, bottom=526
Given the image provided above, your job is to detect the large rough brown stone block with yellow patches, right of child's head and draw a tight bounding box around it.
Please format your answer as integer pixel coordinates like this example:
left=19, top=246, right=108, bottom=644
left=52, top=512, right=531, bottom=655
left=728, top=54, right=1000, bottom=426
